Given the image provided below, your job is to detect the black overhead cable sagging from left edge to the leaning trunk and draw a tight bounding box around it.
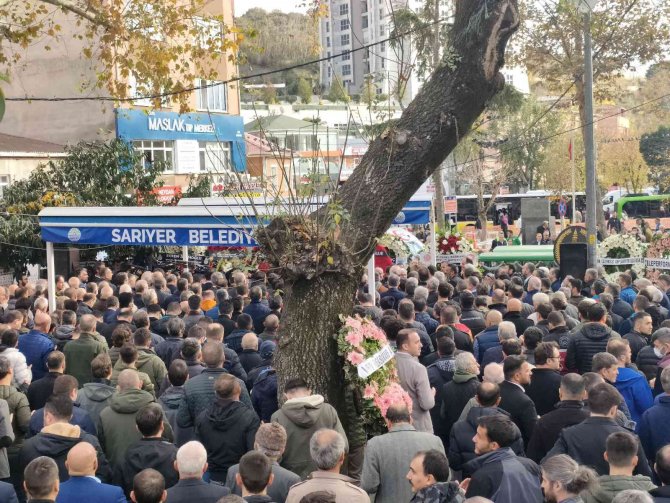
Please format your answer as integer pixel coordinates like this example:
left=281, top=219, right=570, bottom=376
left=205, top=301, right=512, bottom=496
left=5, top=11, right=451, bottom=102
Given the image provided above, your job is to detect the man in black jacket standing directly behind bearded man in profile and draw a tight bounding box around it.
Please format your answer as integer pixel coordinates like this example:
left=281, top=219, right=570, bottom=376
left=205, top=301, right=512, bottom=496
left=447, top=382, right=523, bottom=478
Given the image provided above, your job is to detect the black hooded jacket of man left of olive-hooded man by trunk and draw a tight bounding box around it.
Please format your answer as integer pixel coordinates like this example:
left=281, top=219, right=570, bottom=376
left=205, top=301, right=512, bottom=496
left=195, top=398, right=261, bottom=483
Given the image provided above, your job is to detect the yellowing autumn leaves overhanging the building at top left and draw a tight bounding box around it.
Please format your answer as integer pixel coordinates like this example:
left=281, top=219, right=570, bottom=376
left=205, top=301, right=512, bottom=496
left=0, top=0, right=244, bottom=109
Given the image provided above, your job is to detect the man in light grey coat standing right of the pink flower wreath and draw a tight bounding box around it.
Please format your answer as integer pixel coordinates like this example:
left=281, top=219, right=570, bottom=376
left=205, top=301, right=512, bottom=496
left=395, top=328, right=435, bottom=433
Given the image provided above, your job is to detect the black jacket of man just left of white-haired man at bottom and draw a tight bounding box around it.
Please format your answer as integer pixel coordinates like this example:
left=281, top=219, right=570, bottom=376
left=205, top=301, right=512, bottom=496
left=114, top=438, right=179, bottom=497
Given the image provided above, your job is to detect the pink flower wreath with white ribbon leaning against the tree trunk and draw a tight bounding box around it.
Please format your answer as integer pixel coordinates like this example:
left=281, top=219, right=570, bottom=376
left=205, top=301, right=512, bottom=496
left=337, top=316, right=412, bottom=433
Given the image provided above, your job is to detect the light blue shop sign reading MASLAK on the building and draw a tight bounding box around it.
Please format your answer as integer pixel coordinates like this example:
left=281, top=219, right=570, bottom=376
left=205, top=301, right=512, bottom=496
left=115, top=108, right=246, bottom=171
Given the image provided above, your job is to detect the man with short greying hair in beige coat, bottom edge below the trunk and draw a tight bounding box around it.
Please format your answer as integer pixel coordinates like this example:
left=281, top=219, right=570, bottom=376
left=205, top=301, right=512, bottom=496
left=286, top=428, right=370, bottom=503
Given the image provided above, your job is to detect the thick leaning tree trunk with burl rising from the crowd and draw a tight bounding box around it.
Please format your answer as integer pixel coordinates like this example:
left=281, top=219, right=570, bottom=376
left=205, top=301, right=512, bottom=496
left=258, top=0, right=519, bottom=403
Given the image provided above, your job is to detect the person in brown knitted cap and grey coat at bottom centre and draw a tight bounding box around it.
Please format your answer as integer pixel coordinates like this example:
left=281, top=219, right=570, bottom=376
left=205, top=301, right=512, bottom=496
left=226, top=423, right=300, bottom=503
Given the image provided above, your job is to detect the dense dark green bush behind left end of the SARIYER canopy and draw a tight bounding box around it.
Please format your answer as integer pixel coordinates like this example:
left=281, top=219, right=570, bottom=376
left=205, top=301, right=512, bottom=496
left=0, top=140, right=166, bottom=272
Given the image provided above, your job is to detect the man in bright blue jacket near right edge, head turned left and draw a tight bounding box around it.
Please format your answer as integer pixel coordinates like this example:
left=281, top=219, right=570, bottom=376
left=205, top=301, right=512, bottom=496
left=607, top=339, right=654, bottom=430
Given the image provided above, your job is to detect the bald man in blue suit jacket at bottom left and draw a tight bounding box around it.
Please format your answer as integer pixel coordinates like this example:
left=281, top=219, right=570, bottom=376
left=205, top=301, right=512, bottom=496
left=58, top=442, right=126, bottom=503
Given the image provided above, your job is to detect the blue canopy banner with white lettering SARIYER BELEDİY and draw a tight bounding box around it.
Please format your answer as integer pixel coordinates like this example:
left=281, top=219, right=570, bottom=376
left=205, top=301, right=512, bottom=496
left=42, top=227, right=258, bottom=247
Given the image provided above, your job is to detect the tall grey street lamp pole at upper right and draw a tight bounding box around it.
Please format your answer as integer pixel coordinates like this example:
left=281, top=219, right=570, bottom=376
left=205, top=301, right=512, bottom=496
left=573, top=0, right=599, bottom=268
